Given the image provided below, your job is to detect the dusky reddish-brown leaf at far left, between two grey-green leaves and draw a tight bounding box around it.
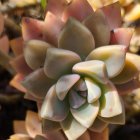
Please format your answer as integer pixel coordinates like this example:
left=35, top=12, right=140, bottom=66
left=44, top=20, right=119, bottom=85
left=10, top=54, right=32, bottom=75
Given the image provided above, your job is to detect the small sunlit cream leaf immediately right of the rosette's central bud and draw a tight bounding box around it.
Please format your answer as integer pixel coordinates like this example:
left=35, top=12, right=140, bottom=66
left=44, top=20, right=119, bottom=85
left=85, top=78, right=101, bottom=103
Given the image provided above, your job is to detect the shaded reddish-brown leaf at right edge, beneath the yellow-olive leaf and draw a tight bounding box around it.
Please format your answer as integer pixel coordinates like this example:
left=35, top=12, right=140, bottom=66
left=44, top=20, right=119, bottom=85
left=116, top=79, right=140, bottom=96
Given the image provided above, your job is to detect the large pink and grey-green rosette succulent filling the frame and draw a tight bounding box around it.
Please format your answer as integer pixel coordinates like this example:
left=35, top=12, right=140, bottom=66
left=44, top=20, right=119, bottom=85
left=8, top=0, right=140, bottom=140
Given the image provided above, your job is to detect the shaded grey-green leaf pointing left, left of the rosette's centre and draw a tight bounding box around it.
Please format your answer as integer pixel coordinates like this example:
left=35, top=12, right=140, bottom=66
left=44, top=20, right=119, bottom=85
left=22, top=68, right=54, bottom=99
